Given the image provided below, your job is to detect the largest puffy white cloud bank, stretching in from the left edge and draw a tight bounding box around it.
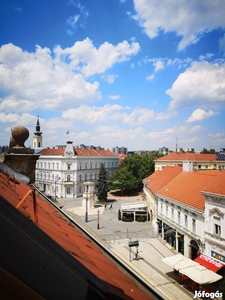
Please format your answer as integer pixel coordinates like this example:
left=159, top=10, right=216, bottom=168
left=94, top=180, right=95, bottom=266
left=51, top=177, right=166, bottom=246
left=0, top=39, right=139, bottom=112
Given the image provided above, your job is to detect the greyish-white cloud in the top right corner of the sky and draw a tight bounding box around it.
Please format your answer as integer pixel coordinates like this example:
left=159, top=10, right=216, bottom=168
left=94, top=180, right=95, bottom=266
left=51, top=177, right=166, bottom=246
left=134, top=0, right=225, bottom=50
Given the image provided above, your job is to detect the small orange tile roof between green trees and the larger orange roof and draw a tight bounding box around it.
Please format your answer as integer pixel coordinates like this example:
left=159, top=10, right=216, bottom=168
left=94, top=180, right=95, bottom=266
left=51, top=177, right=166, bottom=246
left=146, top=166, right=182, bottom=194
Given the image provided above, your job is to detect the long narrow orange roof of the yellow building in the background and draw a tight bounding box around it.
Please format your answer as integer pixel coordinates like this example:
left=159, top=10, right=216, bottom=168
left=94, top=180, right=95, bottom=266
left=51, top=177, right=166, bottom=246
left=155, top=152, right=218, bottom=162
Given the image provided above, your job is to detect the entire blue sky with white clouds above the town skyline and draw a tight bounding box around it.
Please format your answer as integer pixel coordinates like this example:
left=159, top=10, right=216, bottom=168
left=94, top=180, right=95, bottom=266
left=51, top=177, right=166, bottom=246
left=0, top=0, right=225, bottom=151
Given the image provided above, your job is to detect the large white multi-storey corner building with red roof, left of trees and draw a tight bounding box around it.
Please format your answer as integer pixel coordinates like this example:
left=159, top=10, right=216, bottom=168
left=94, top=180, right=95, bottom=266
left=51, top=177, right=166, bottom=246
left=35, top=142, right=119, bottom=198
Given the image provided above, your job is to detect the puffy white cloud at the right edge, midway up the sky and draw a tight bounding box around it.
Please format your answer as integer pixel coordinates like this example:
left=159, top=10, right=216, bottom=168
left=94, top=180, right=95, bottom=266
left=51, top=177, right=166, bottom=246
left=166, top=61, right=225, bottom=110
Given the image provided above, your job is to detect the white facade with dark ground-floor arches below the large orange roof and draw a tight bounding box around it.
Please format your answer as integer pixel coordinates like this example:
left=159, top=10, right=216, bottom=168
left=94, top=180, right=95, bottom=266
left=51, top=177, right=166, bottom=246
left=158, top=195, right=204, bottom=259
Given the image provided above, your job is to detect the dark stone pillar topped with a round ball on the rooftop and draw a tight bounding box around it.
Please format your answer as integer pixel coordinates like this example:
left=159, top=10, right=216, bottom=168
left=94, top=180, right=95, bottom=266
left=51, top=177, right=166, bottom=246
left=4, top=126, right=40, bottom=184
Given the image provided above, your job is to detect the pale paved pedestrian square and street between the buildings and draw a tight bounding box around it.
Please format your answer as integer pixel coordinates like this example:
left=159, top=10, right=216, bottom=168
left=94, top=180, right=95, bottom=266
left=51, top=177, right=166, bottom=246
left=58, top=197, right=198, bottom=300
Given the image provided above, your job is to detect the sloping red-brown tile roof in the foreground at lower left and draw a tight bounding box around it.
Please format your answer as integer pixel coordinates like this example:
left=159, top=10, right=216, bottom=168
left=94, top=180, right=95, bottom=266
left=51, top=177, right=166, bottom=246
left=0, top=173, right=151, bottom=300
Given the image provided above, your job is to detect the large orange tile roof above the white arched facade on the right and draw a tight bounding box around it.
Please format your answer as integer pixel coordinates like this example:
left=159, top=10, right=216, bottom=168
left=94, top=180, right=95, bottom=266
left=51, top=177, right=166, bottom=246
left=157, top=170, right=220, bottom=211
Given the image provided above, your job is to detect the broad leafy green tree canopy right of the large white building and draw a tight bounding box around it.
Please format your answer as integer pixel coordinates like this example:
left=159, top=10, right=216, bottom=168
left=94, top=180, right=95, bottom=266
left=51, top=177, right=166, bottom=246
left=109, top=153, right=163, bottom=191
